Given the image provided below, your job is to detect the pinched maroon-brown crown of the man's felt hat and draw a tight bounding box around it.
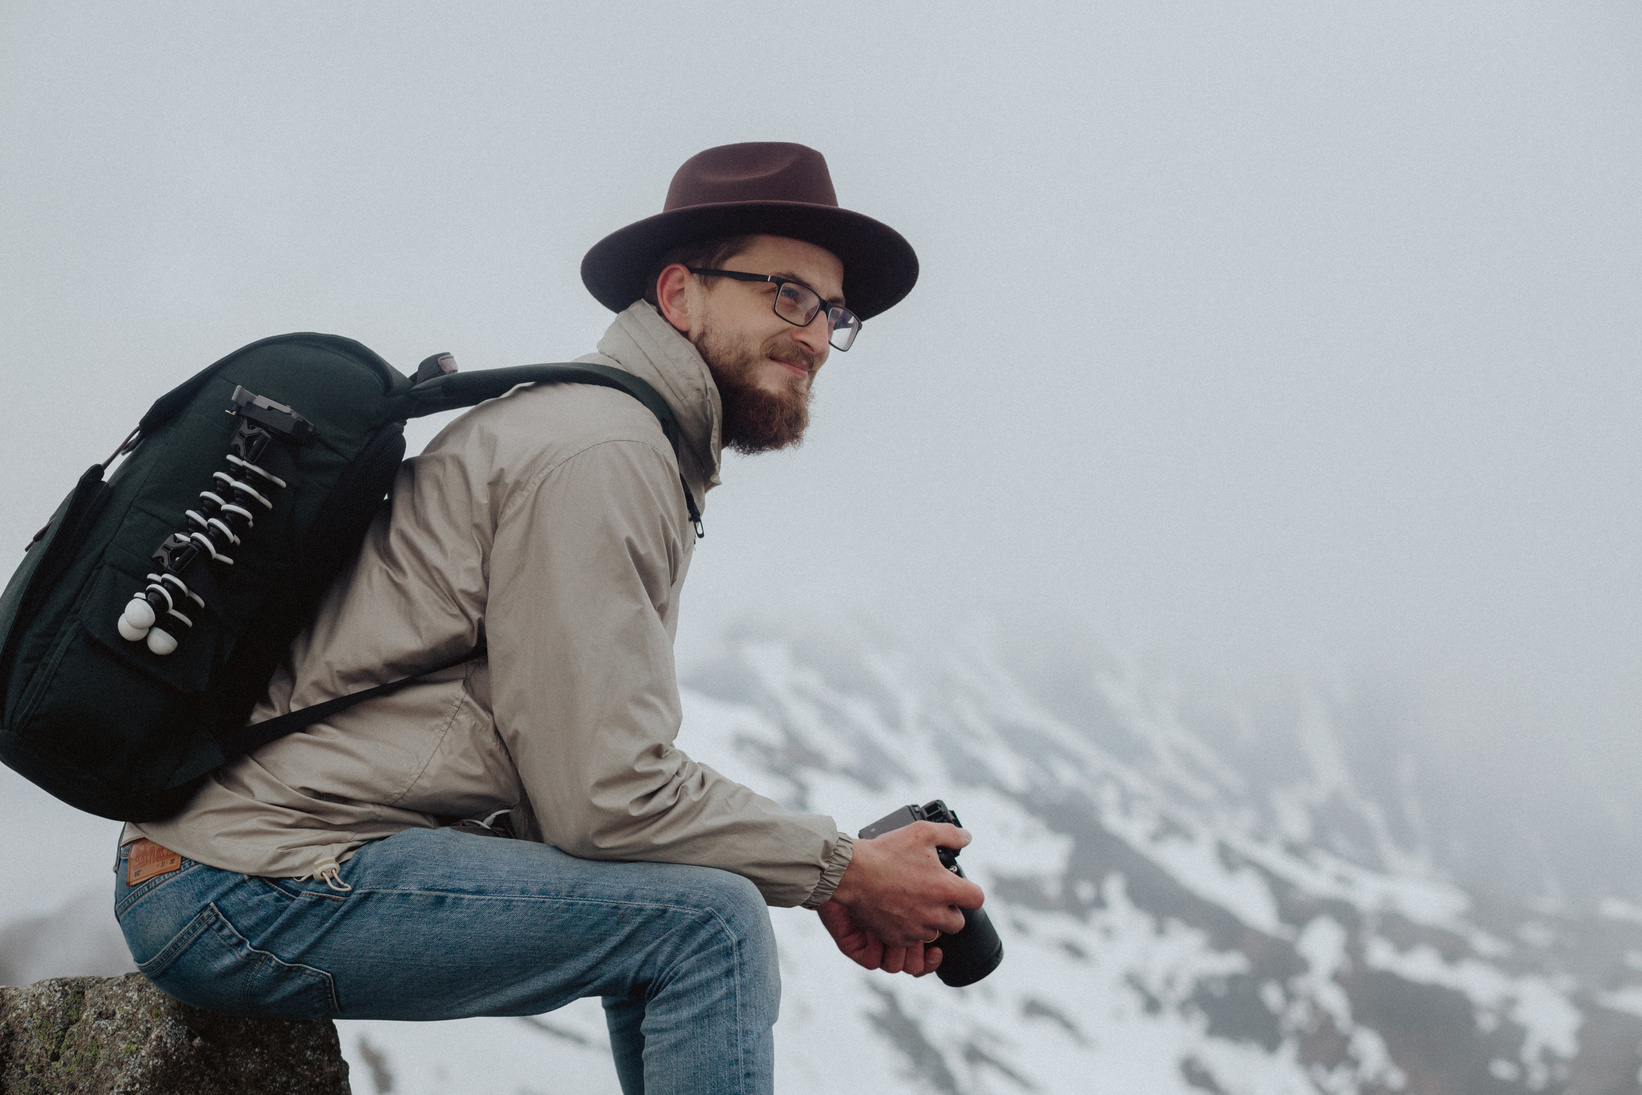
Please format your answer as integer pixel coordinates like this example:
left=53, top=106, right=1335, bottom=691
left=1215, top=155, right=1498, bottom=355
left=662, top=141, right=837, bottom=213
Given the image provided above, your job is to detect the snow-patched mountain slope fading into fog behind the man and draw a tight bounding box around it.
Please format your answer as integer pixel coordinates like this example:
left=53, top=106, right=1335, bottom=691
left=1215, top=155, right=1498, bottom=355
left=0, top=627, right=1642, bottom=1095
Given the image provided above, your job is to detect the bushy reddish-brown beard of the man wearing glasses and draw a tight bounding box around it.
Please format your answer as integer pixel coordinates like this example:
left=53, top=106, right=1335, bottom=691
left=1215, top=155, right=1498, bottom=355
left=696, top=327, right=823, bottom=456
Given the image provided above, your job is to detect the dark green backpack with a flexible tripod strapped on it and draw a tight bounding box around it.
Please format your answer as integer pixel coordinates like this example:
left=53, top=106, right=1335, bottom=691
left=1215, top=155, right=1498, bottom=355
left=0, top=335, right=699, bottom=821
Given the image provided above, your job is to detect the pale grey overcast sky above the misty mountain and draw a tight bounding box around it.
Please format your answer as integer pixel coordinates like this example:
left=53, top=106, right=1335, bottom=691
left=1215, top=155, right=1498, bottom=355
left=0, top=0, right=1642, bottom=919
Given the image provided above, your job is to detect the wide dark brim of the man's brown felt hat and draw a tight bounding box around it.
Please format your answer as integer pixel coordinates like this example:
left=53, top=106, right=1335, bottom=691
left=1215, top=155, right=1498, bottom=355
left=581, top=202, right=918, bottom=320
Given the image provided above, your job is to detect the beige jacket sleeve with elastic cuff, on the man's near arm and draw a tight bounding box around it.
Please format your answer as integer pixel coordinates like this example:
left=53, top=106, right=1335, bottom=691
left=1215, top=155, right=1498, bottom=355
left=484, top=440, right=851, bottom=906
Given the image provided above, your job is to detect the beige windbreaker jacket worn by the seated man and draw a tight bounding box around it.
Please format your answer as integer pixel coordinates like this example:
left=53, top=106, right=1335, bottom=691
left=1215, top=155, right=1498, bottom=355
left=125, top=302, right=851, bottom=908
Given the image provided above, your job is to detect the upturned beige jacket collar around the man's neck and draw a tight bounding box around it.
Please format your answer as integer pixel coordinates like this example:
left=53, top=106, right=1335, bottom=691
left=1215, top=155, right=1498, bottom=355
left=576, top=300, right=724, bottom=507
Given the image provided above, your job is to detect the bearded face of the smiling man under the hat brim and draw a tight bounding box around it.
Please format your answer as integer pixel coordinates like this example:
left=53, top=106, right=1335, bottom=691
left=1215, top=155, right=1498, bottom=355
left=691, top=236, right=844, bottom=453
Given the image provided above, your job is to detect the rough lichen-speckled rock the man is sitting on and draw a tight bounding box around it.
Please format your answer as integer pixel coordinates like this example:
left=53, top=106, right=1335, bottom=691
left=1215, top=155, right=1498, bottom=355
left=0, top=974, right=351, bottom=1095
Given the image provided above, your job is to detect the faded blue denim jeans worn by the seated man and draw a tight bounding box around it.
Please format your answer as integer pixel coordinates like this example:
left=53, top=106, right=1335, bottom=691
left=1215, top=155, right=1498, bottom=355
left=115, top=829, right=782, bottom=1095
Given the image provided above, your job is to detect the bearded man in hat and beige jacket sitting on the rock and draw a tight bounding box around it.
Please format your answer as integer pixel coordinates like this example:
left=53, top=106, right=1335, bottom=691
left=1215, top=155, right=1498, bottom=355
left=117, top=144, right=982, bottom=1095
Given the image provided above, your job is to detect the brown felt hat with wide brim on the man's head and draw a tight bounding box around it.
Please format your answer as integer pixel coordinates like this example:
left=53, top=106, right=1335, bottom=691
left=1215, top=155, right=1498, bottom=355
left=581, top=141, right=918, bottom=320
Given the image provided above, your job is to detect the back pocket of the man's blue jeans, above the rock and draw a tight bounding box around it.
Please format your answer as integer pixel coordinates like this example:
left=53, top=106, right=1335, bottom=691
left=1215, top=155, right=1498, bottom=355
left=136, top=903, right=338, bottom=1019
